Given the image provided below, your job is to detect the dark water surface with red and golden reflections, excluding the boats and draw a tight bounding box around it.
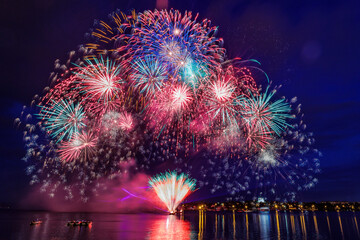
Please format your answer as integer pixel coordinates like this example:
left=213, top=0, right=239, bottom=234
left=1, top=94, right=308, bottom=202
left=0, top=211, right=360, bottom=240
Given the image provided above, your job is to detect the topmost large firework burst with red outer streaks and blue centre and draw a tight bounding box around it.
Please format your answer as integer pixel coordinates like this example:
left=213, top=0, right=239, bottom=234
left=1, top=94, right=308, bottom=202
left=129, top=10, right=225, bottom=73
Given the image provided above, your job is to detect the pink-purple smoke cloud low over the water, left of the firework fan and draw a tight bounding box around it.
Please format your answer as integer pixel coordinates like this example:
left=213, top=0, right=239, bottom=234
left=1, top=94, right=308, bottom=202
left=20, top=174, right=165, bottom=213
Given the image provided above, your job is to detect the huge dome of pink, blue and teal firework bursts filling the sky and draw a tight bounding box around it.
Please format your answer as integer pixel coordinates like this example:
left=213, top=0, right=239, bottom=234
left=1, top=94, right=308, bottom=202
left=16, top=10, right=321, bottom=202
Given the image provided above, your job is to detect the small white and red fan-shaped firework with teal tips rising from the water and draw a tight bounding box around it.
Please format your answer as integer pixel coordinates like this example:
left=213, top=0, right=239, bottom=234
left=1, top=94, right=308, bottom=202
left=149, top=172, right=195, bottom=213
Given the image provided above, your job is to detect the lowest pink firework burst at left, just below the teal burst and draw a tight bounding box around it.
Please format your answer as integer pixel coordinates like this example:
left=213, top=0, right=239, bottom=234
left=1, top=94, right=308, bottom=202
left=58, top=132, right=98, bottom=162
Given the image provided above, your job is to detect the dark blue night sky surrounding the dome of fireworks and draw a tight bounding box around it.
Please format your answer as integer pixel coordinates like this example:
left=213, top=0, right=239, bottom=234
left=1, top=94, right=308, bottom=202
left=0, top=0, right=360, bottom=205
